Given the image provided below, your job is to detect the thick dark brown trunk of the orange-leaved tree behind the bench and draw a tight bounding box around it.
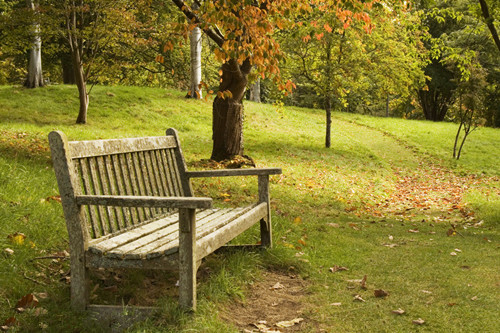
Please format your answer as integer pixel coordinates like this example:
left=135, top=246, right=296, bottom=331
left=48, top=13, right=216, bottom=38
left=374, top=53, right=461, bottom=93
left=211, top=59, right=251, bottom=161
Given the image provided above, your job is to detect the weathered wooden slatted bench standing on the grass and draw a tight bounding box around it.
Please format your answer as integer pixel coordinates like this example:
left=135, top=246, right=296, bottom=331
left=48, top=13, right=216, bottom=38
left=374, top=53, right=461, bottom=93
left=49, top=129, right=281, bottom=310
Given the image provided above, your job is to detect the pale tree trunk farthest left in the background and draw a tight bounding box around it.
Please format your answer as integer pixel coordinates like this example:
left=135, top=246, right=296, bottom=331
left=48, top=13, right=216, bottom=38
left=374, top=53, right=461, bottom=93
left=24, top=0, right=44, bottom=88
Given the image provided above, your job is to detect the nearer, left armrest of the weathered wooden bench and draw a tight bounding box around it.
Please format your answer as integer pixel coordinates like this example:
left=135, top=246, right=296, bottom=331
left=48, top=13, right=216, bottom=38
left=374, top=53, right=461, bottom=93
left=76, top=195, right=212, bottom=209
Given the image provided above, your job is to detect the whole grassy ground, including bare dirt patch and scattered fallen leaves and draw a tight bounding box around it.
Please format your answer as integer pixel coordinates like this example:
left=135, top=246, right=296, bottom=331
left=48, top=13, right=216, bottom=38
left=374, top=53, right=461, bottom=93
left=0, top=86, right=500, bottom=332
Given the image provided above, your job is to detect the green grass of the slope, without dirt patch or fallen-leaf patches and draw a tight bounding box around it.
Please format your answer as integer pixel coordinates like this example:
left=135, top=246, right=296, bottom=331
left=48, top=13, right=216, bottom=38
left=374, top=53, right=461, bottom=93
left=0, top=86, right=500, bottom=332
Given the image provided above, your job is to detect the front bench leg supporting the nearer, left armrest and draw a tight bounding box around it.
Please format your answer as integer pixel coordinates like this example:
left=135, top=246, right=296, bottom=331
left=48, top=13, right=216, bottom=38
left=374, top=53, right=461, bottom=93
left=179, top=208, right=198, bottom=311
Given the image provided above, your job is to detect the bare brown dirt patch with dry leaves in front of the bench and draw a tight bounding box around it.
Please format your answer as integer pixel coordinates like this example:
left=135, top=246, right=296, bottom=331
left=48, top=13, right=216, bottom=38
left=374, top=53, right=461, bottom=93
left=220, top=271, right=311, bottom=332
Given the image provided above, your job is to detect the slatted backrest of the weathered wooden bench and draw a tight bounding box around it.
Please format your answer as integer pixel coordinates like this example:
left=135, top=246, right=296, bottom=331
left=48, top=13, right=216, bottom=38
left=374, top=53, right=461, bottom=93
left=49, top=129, right=192, bottom=239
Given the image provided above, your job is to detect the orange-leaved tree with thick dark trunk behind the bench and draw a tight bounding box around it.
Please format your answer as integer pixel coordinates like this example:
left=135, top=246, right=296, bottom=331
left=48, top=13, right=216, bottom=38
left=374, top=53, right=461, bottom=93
left=172, top=0, right=375, bottom=161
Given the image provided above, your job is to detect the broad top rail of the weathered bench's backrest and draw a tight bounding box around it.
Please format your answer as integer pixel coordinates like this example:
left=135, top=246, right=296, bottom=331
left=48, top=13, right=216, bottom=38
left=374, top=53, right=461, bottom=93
left=69, top=136, right=177, bottom=158
